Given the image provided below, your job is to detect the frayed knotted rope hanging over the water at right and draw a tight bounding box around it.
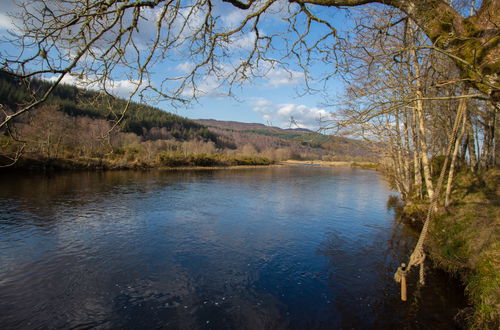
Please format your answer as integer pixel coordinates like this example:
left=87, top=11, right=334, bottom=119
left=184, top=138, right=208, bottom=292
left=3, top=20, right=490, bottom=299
left=394, top=99, right=466, bottom=295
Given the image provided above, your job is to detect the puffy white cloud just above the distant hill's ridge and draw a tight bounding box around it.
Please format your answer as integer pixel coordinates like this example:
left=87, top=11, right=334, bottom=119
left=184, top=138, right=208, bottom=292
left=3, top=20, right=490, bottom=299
left=252, top=98, right=332, bottom=130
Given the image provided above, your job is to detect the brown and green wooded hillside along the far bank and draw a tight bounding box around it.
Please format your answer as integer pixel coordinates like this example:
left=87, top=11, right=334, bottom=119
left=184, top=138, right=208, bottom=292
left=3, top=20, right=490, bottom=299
left=0, top=71, right=376, bottom=168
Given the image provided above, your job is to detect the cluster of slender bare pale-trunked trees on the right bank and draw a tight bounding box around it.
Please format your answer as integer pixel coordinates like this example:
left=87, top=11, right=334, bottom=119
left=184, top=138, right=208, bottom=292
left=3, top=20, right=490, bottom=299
left=324, top=4, right=495, bottom=205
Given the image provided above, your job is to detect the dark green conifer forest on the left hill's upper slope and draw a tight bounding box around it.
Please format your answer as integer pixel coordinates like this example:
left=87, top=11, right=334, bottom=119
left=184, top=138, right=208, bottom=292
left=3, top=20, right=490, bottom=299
left=0, top=70, right=214, bottom=140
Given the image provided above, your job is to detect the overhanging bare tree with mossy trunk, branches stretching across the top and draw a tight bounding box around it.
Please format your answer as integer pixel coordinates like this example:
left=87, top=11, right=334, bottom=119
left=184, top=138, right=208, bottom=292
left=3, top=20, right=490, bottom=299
left=0, top=0, right=500, bottom=128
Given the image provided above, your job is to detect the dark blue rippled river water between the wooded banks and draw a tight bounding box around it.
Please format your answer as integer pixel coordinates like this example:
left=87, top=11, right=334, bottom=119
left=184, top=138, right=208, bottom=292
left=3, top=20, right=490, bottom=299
left=0, top=167, right=463, bottom=329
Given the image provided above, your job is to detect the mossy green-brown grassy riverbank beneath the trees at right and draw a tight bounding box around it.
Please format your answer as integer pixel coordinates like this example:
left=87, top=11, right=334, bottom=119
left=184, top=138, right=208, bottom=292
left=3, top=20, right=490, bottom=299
left=411, top=169, right=500, bottom=329
